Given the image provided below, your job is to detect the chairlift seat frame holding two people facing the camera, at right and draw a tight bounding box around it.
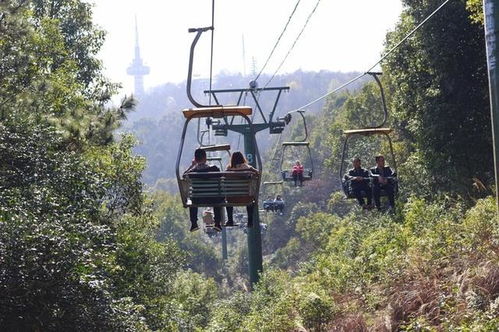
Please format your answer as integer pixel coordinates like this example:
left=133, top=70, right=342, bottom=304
left=339, top=72, right=398, bottom=198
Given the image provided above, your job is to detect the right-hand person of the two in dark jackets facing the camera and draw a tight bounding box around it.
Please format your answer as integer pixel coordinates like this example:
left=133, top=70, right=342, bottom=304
left=371, top=155, right=395, bottom=210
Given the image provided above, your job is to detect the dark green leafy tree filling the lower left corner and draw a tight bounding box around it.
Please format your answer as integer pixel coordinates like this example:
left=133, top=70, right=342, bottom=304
left=0, top=123, right=143, bottom=330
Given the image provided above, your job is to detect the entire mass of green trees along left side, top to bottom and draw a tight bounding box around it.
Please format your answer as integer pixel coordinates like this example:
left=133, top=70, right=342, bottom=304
left=0, top=0, right=213, bottom=331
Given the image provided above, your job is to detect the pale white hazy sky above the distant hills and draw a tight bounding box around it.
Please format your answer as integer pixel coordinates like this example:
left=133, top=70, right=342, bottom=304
left=89, top=0, right=402, bottom=93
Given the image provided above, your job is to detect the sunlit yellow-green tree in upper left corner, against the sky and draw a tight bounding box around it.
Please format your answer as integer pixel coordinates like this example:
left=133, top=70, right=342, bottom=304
left=0, top=0, right=133, bottom=145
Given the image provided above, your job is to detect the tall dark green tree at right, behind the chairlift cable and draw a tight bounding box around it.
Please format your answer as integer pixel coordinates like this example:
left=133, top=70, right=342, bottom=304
left=383, top=0, right=492, bottom=194
